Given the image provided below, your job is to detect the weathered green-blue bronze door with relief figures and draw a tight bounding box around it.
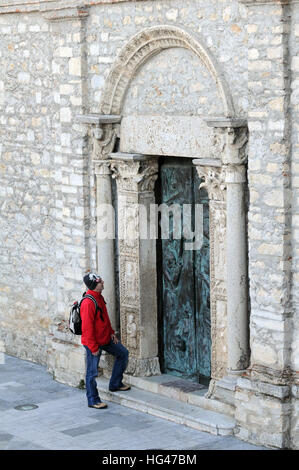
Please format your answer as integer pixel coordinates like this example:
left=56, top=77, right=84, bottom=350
left=157, top=157, right=211, bottom=383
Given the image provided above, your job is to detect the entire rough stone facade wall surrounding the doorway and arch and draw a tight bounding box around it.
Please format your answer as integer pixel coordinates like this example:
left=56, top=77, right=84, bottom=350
left=0, top=0, right=299, bottom=448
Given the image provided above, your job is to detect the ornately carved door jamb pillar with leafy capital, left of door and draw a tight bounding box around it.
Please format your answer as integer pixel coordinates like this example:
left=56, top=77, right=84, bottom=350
left=111, top=153, right=160, bottom=376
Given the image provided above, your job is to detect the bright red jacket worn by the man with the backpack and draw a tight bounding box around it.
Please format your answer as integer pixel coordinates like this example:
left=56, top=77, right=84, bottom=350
left=80, top=290, right=114, bottom=353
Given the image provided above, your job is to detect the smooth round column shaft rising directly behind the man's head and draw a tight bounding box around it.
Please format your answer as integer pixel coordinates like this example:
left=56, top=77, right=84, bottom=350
left=94, top=160, right=117, bottom=329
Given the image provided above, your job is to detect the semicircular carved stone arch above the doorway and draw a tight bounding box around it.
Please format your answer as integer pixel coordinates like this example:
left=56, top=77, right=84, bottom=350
left=100, top=25, right=235, bottom=117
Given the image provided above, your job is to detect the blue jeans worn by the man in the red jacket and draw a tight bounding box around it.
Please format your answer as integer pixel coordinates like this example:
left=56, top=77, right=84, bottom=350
left=84, top=340, right=129, bottom=406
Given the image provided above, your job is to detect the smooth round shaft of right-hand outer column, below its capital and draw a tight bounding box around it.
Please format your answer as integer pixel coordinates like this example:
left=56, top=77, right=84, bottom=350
left=224, top=129, right=249, bottom=374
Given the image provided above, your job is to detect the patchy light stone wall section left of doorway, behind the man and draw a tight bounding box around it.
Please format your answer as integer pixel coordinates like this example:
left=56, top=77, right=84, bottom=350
left=0, top=9, right=95, bottom=363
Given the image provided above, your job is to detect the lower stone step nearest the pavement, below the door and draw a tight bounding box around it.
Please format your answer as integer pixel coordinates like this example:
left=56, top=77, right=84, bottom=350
left=97, top=376, right=235, bottom=436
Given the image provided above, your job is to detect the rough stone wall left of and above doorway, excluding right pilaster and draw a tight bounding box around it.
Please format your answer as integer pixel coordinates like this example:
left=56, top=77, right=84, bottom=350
left=0, top=0, right=247, bottom=374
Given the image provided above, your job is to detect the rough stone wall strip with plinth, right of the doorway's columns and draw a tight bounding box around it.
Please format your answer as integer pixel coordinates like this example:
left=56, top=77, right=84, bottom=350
left=235, top=1, right=298, bottom=447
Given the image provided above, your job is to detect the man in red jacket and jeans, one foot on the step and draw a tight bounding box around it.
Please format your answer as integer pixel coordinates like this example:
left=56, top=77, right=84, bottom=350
left=80, top=273, right=131, bottom=409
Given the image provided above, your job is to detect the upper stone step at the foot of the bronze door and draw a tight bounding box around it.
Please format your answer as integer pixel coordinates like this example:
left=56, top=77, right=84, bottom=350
left=124, top=374, right=235, bottom=417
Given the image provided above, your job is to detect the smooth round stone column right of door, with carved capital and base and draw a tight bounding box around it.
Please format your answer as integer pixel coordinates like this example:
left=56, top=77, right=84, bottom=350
left=206, top=118, right=249, bottom=404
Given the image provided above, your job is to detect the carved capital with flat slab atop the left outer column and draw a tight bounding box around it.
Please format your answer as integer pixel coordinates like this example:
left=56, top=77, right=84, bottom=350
left=76, top=114, right=121, bottom=160
